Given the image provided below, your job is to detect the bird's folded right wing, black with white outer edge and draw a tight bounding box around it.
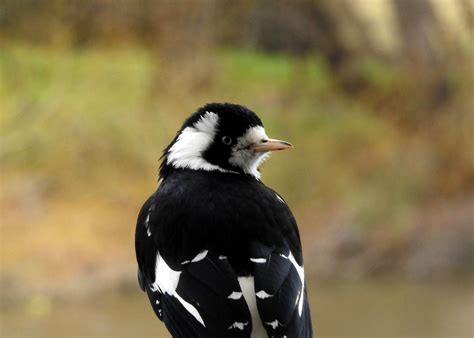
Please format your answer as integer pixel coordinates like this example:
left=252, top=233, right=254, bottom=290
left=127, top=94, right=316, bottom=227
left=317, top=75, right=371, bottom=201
left=250, top=242, right=312, bottom=338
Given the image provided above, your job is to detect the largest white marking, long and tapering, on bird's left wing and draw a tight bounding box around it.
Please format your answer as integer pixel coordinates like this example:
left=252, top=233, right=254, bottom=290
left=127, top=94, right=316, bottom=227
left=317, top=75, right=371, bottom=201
left=151, top=252, right=206, bottom=327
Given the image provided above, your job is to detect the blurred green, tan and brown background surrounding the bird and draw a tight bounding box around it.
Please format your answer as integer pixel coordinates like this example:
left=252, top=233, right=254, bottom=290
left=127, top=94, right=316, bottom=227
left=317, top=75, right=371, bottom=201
left=0, top=0, right=474, bottom=337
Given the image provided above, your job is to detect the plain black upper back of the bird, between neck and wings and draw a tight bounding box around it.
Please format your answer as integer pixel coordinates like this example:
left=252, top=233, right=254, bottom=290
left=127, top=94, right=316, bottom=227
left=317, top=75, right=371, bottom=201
left=137, top=170, right=301, bottom=265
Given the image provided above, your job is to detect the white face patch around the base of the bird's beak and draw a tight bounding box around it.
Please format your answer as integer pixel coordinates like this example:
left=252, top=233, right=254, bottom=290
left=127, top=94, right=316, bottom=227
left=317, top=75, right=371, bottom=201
left=229, top=126, right=270, bottom=178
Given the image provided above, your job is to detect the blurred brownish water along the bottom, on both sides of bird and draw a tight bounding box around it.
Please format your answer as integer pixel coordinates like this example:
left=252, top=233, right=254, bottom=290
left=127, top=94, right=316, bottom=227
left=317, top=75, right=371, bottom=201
left=0, top=281, right=474, bottom=337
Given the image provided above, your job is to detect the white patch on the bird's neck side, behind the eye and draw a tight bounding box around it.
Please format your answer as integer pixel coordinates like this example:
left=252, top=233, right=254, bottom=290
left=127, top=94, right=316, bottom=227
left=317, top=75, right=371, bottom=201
left=166, top=112, right=235, bottom=172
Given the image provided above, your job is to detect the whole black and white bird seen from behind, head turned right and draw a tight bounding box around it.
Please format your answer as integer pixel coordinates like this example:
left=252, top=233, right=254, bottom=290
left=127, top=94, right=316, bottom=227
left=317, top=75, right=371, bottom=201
left=135, top=103, right=312, bottom=338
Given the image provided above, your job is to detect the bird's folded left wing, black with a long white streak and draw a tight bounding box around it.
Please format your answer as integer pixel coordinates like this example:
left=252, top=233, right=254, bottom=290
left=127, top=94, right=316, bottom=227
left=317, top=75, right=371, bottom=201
left=136, top=196, right=252, bottom=337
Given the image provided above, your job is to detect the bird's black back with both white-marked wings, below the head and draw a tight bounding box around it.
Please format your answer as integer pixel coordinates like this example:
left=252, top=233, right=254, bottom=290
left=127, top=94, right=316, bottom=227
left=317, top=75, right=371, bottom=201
left=136, top=170, right=311, bottom=337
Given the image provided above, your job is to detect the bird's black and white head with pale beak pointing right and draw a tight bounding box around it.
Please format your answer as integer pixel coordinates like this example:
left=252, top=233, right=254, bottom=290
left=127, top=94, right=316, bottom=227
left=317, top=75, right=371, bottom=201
left=160, top=103, right=291, bottom=178
